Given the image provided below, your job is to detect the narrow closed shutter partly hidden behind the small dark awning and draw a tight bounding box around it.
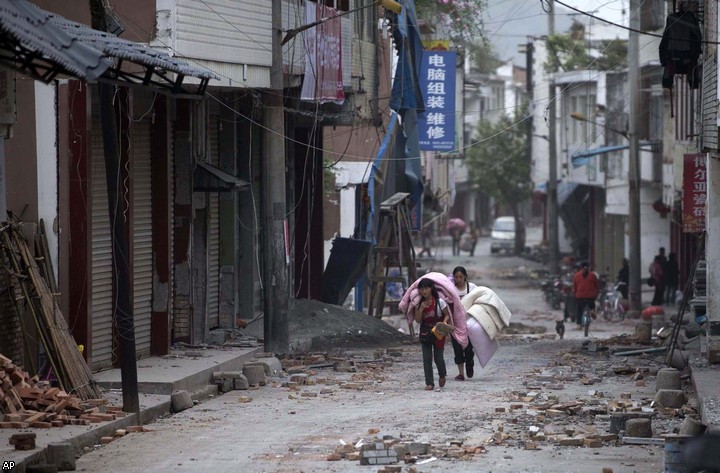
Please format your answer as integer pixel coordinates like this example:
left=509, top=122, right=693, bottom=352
left=207, top=116, right=220, bottom=329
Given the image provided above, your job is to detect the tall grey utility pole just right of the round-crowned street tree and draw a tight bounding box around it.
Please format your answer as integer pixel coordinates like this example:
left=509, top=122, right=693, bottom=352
left=545, top=0, right=560, bottom=274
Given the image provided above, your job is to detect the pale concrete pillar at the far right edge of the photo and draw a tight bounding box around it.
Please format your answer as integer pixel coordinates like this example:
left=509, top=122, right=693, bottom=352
left=705, top=154, right=720, bottom=363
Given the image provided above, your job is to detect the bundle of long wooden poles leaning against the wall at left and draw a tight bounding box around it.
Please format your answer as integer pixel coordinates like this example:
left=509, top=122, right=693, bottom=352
left=0, top=223, right=100, bottom=399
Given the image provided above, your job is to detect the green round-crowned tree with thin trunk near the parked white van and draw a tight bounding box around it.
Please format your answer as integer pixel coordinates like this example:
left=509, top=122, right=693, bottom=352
left=465, top=108, right=532, bottom=253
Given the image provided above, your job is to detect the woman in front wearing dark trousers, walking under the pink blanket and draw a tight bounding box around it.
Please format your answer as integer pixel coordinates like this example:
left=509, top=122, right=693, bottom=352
left=415, top=278, right=450, bottom=391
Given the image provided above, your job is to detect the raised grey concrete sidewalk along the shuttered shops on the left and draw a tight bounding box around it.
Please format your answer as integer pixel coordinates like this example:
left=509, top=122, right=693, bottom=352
left=0, top=347, right=263, bottom=473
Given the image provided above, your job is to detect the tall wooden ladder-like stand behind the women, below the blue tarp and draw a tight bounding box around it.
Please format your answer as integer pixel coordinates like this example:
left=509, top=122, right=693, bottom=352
left=368, top=192, right=417, bottom=334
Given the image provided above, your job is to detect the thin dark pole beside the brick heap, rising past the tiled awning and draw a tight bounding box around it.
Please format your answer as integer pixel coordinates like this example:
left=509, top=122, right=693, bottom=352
left=90, top=0, right=140, bottom=412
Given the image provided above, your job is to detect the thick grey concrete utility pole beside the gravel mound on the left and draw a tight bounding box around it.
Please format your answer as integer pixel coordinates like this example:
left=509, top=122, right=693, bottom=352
left=263, top=0, right=290, bottom=353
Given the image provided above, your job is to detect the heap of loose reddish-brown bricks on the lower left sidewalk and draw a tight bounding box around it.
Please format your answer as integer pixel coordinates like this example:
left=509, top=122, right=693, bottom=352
left=0, top=354, right=125, bottom=429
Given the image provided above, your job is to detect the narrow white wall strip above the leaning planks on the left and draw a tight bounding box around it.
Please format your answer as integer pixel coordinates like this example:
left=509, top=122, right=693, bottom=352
left=35, top=81, right=59, bottom=281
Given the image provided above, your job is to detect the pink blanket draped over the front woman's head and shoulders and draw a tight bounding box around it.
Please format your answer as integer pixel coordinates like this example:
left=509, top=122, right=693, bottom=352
left=398, top=273, right=468, bottom=348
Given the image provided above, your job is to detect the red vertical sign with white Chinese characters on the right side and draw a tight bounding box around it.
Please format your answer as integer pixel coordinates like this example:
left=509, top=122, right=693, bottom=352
left=683, top=153, right=707, bottom=233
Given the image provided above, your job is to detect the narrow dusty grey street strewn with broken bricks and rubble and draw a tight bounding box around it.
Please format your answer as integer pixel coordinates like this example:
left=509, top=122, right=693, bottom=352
left=77, top=230, right=668, bottom=473
